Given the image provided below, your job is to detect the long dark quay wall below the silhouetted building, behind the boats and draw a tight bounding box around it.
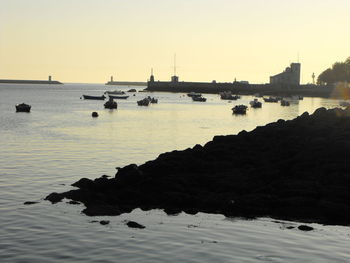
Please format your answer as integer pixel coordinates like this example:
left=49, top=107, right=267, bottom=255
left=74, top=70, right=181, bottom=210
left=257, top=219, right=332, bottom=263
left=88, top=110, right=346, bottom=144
left=146, top=81, right=350, bottom=98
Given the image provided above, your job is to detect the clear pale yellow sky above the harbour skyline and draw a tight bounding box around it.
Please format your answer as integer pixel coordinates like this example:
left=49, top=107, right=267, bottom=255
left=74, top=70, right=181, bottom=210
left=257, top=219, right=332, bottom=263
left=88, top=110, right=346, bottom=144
left=0, top=0, right=350, bottom=83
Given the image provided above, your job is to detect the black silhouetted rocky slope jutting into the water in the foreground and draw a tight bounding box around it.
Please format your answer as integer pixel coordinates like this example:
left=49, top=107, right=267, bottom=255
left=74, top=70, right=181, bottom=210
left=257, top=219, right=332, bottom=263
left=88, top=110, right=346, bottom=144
left=46, top=108, right=350, bottom=225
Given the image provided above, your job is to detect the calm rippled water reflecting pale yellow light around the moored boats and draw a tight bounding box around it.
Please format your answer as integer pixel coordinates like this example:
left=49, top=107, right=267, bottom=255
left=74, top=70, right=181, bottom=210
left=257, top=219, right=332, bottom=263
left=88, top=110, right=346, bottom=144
left=0, top=84, right=350, bottom=262
